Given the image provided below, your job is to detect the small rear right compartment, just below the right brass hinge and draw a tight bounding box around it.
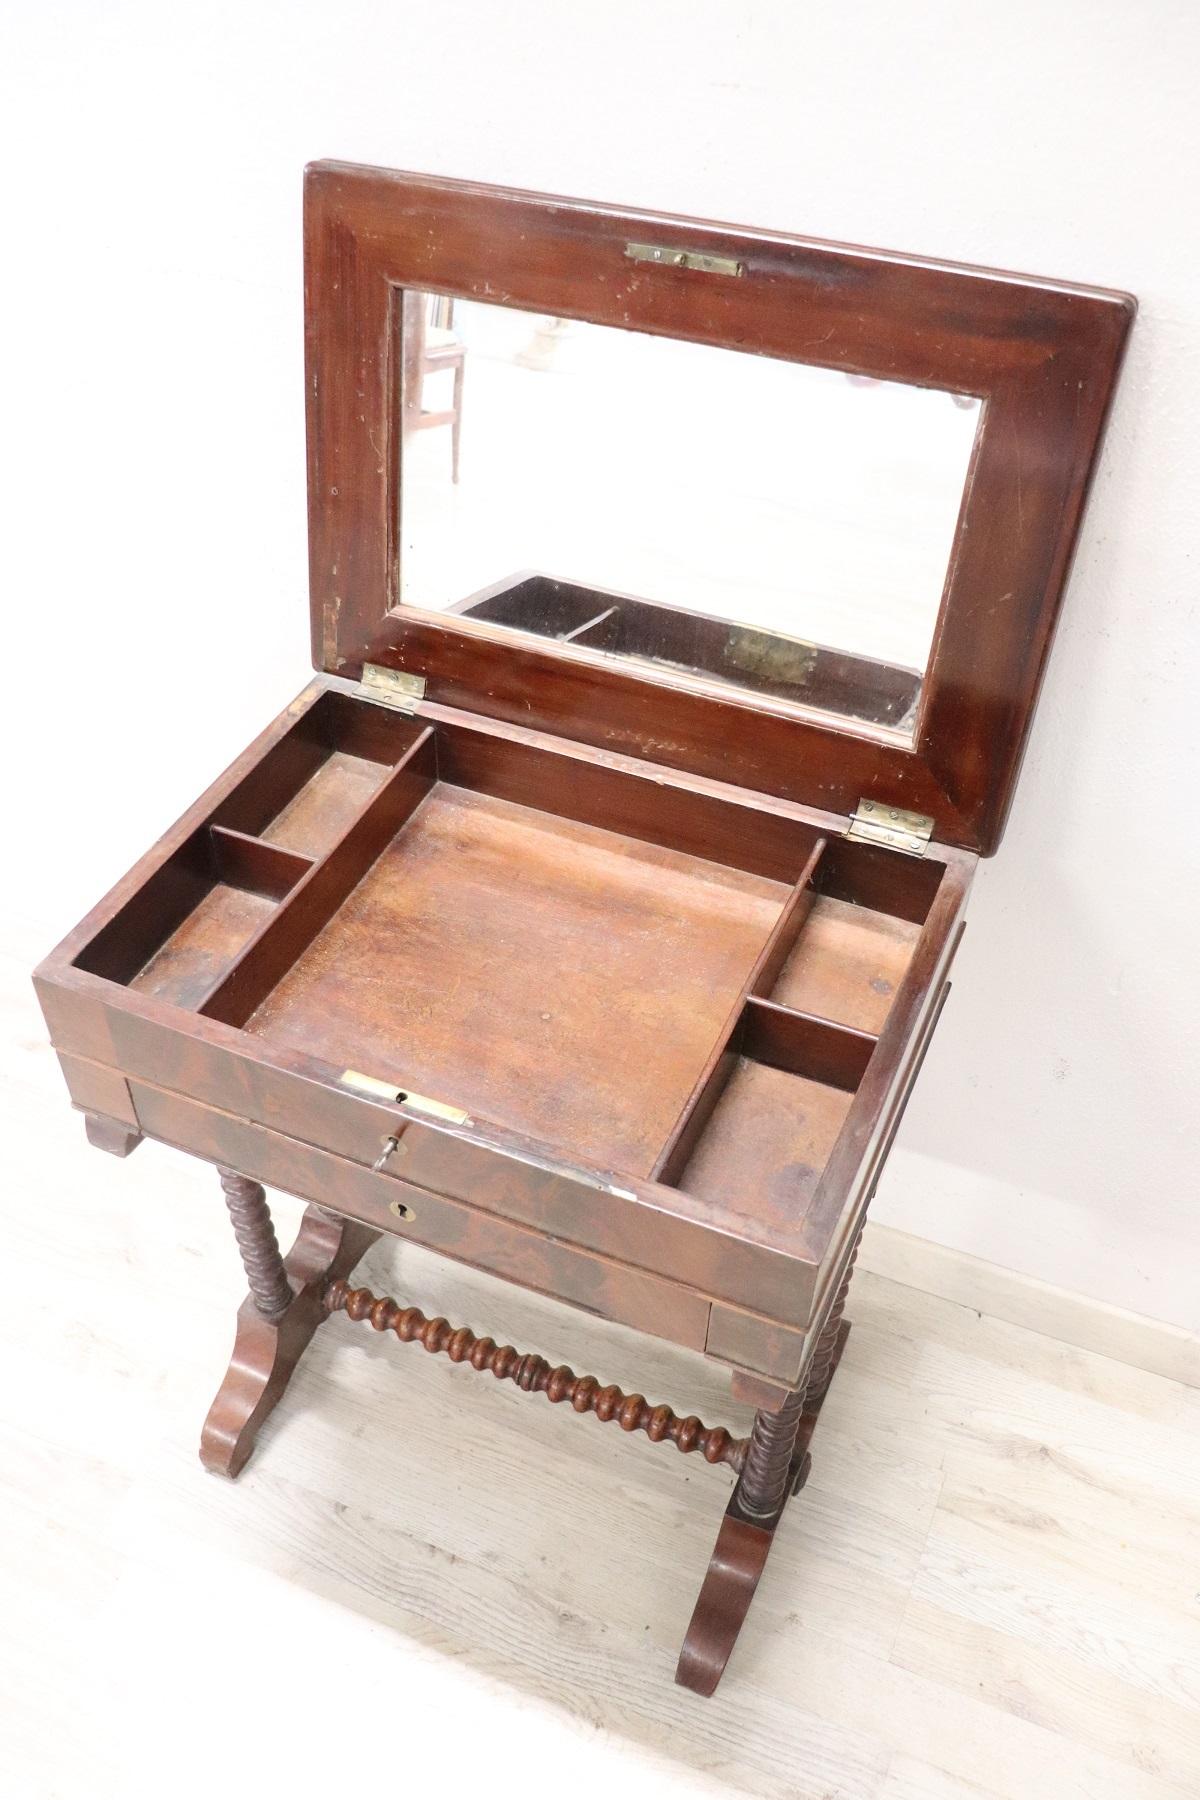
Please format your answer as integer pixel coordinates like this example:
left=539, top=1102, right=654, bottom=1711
left=766, top=839, right=943, bottom=1031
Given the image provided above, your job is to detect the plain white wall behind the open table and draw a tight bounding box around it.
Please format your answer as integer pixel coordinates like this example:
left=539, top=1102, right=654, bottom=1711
left=0, top=0, right=1200, bottom=1325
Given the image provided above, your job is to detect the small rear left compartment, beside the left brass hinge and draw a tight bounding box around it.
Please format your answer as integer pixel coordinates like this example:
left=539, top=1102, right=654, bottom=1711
left=214, top=693, right=421, bottom=857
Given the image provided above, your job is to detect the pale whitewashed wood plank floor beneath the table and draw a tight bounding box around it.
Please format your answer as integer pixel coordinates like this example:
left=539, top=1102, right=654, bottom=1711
left=0, top=914, right=1200, bottom=1800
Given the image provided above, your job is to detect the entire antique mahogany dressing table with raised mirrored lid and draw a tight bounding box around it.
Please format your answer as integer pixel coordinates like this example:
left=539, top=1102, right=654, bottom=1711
left=36, top=164, right=1133, bottom=1694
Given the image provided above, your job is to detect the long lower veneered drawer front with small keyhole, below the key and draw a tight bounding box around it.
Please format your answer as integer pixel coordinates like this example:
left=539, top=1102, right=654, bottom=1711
left=130, top=1082, right=709, bottom=1350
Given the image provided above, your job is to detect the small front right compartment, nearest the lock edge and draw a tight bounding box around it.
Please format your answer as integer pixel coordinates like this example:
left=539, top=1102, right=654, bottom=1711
left=660, top=999, right=876, bottom=1228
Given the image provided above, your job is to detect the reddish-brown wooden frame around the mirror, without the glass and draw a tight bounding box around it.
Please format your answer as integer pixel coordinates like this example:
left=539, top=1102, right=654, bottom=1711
left=304, top=162, right=1135, bottom=855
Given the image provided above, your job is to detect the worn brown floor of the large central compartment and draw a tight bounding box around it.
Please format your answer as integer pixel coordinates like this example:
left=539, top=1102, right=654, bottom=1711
left=248, top=783, right=788, bottom=1174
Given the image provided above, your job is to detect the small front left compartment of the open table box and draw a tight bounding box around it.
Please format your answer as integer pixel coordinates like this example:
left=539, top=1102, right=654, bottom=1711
left=77, top=826, right=313, bottom=1008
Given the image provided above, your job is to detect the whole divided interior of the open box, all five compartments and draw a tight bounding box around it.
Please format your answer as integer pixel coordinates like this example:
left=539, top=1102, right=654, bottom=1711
left=76, top=691, right=945, bottom=1229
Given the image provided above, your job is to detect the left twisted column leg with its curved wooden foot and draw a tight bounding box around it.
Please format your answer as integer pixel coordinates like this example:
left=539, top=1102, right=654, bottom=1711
left=200, top=1168, right=380, bottom=1476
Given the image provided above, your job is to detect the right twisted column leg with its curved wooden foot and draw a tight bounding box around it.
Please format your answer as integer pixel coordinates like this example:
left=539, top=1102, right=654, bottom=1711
left=675, top=1216, right=858, bottom=1696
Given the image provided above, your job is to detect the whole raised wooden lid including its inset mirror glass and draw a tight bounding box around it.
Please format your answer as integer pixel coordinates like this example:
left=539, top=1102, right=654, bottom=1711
left=306, top=164, right=1133, bottom=853
